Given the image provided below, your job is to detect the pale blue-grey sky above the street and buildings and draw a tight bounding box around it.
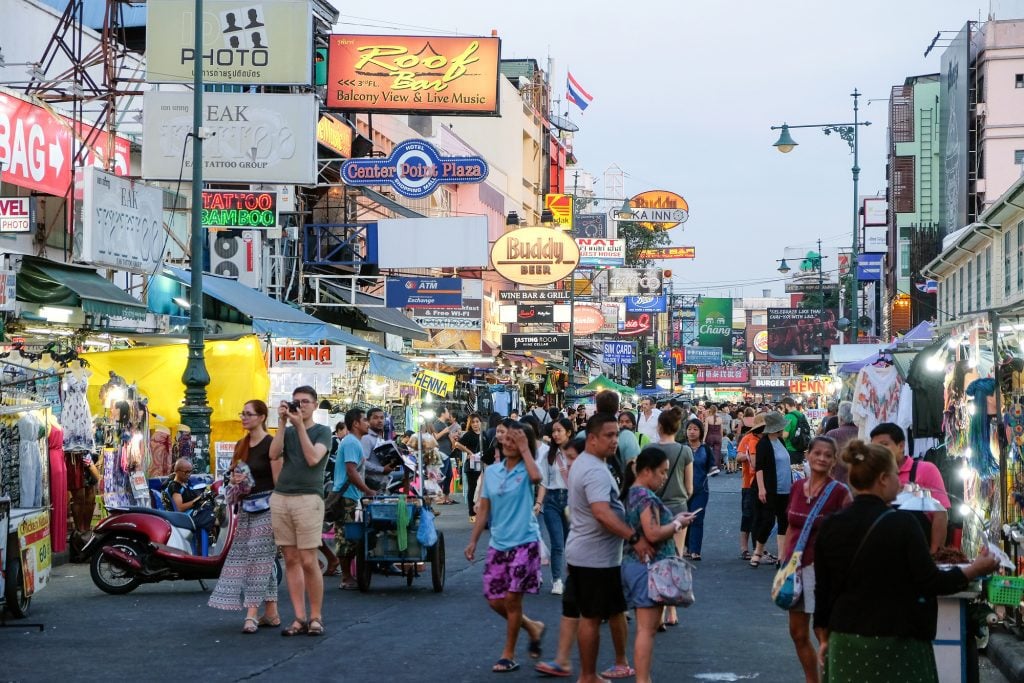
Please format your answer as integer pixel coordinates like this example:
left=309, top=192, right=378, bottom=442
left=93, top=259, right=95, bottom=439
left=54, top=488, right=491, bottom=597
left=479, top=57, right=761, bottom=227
left=335, top=0, right=1024, bottom=297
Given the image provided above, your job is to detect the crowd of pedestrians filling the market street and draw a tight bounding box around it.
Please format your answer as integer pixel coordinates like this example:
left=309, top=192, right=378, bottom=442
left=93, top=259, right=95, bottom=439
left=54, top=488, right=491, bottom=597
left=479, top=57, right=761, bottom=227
left=199, top=386, right=996, bottom=683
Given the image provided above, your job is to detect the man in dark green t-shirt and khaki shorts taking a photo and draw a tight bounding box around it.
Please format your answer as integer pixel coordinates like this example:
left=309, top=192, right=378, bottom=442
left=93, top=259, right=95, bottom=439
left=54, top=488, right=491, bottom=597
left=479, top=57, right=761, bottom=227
left=270, top=386, right=331, bottom=636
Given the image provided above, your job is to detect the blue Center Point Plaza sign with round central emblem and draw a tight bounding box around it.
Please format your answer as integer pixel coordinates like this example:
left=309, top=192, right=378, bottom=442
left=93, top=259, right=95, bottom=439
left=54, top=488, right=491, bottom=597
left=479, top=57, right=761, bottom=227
left=341, top=140, right=487, bottom=199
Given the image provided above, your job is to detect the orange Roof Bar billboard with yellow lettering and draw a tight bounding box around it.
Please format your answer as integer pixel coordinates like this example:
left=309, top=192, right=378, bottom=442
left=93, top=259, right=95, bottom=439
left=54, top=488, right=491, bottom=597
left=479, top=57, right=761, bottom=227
left=327, top=34, right=501, bottom=116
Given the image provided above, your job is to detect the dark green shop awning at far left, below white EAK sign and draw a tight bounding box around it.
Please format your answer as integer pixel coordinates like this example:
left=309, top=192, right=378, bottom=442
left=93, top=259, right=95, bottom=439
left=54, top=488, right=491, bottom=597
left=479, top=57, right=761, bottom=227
left=17, top=256, right=146, bottom=319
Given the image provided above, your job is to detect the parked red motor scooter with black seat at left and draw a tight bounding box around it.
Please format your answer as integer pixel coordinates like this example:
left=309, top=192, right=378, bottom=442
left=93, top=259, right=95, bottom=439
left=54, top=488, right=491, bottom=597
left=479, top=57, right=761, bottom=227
left=83, top=482, right=281, bottom=595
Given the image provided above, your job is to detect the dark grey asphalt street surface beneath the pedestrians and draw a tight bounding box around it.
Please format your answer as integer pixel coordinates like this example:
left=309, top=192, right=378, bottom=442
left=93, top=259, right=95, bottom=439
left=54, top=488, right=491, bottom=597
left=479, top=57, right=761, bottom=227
left=0, top=474, right=1006, bottom=683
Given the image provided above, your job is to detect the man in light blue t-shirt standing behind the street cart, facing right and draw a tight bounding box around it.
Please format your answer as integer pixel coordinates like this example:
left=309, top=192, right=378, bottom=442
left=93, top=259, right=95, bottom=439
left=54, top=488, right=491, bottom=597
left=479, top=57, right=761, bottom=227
left=334, top=408, right=376, bottom=591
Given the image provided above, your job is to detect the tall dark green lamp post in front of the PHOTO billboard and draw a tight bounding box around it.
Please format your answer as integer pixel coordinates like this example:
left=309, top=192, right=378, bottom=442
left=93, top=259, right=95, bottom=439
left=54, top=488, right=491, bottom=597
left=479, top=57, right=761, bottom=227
left=178, top=0, right=213, bottom=469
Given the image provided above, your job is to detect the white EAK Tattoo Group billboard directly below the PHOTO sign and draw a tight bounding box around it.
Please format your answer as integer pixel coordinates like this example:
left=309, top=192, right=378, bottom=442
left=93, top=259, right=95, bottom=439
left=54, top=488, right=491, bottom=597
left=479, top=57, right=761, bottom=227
left=142, top=90, right=316, bottom=185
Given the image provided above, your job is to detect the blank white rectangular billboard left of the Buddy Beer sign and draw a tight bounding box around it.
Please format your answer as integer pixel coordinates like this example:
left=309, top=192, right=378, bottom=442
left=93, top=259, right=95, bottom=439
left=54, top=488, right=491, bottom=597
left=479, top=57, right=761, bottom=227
left=377, top=216, right=487, bottom=268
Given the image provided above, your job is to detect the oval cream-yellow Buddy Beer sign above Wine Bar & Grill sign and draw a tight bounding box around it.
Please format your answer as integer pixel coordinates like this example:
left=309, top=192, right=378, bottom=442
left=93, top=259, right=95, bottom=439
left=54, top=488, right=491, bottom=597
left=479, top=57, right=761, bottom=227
left=490, top=227, right=580, bottom=285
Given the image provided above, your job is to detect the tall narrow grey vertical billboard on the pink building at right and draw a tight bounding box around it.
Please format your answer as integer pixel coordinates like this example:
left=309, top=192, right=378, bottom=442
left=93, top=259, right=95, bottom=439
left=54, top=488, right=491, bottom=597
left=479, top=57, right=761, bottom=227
left=939, top=22, right=971, bottom=234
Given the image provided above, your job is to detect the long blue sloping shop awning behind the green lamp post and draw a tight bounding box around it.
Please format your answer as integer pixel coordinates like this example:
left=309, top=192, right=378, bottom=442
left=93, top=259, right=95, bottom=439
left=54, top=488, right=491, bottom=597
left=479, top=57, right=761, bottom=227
left=163, top=265, right=404, bottom=360
